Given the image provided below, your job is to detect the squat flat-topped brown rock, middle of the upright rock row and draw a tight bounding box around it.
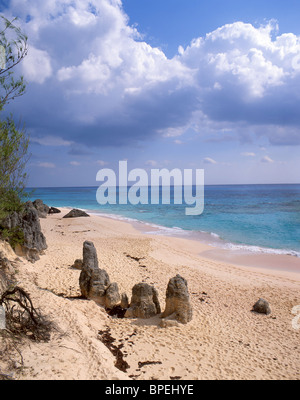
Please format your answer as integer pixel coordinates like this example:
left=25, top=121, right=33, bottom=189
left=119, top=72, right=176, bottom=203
left=125, top=283, right=161, bottom=319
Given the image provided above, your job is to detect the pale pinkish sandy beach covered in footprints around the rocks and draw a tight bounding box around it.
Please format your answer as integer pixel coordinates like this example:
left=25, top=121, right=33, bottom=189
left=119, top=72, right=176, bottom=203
left=2, top=209, right=300, bottom=380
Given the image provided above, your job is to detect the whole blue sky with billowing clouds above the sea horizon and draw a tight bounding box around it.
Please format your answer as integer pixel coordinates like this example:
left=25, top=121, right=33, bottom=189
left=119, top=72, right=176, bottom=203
left=0, top=0, right=300, bottom=187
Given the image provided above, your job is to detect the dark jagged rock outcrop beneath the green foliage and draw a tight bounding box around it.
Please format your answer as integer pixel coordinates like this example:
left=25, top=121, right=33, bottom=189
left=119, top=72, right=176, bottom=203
left=0, top=201, right=47, bottom=262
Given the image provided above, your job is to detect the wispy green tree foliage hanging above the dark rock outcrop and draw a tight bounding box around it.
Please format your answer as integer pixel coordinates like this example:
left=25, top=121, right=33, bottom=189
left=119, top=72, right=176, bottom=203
left=0, top=16, right=29, bottom=238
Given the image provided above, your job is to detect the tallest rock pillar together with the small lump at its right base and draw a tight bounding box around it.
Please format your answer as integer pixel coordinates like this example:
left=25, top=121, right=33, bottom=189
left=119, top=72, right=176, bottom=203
left=79, top=241, right=121, bottom=308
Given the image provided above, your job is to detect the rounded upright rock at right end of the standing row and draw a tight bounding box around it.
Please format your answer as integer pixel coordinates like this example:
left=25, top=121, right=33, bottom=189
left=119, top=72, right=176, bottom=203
left=162, top=275, right=193, bottom=324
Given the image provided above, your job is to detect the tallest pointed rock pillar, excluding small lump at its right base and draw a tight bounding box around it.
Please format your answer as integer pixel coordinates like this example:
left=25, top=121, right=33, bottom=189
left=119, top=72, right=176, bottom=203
left=79, top=241, right=110, bottom=305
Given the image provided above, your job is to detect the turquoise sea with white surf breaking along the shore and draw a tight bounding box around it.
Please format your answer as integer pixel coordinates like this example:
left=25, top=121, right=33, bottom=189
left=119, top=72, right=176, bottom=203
left=25, top=185, right=300, bottom=257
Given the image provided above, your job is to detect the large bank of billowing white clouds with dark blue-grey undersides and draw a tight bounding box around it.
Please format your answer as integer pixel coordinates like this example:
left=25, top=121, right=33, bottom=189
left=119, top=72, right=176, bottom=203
left=5, top=0, right=300, bottom=148
